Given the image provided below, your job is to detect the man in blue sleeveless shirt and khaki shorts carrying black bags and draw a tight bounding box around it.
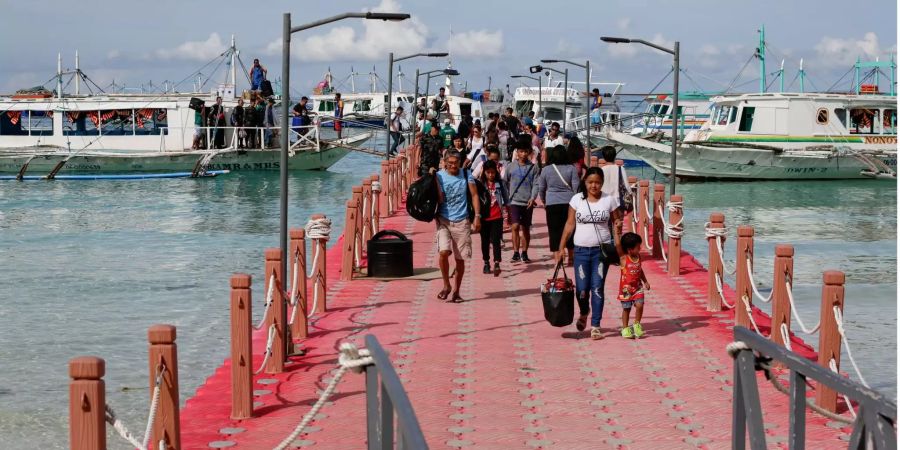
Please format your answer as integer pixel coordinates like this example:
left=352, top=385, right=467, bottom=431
left=436, top=151, right=481, bottom=303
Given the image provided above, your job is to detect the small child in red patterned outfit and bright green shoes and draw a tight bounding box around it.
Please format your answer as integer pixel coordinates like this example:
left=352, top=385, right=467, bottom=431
left=615, top=232, right=650, bottom=339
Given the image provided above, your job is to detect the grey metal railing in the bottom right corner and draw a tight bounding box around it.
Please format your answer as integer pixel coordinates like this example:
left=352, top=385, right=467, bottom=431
left=729, top=326, right=897, bottom=450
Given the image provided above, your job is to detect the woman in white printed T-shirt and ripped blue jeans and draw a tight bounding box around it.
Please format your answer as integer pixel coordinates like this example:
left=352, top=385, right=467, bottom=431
left=556, top=167, right=621, bottom=339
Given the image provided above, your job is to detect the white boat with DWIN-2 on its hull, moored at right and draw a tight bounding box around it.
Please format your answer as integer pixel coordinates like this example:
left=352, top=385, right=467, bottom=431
left=603, top=93, right=897, bottom=180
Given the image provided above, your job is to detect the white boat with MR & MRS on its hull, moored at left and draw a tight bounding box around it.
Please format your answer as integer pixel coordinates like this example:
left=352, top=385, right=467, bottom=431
left=0, top=38, right=373, bottom=179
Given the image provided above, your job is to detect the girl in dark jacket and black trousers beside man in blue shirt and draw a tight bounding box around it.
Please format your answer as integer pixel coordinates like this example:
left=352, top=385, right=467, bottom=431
left=479, top=159, right=509, bottom=277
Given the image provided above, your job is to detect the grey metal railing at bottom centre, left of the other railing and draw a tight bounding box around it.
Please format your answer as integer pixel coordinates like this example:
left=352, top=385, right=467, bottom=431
left=366, top=334, right=428, bottom=450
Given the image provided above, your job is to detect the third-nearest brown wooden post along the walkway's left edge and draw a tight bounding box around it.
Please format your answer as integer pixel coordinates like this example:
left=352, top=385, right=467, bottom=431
left=231, top=273, right=253, bottom=419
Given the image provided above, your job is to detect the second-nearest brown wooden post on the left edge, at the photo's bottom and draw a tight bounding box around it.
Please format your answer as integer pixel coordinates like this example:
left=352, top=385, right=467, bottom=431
left=147, top=325, right=181, bottom=450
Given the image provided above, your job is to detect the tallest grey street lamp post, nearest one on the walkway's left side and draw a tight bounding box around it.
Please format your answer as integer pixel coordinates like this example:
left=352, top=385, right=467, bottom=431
left=280, top=12, right=410, bottom=355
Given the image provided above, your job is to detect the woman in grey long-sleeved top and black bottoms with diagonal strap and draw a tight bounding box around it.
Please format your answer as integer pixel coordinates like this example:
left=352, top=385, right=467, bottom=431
left=528, top=145, right=578, bottom=265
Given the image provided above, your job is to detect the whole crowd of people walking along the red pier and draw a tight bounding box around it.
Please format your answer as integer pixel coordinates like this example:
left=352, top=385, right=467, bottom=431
left=416, top=109, right=650, bottom=339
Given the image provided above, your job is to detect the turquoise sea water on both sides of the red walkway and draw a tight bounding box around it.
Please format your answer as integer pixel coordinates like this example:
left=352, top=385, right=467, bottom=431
left=0, top=154, right=897, bottom=448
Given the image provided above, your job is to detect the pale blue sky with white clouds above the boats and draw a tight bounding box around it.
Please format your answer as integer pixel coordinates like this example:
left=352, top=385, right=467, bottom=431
left=0, top=0, right=897, bottom=94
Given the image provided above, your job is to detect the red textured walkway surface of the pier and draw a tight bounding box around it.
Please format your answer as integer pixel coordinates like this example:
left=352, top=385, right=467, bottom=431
left=181, top=201, right=850, bottom=449
